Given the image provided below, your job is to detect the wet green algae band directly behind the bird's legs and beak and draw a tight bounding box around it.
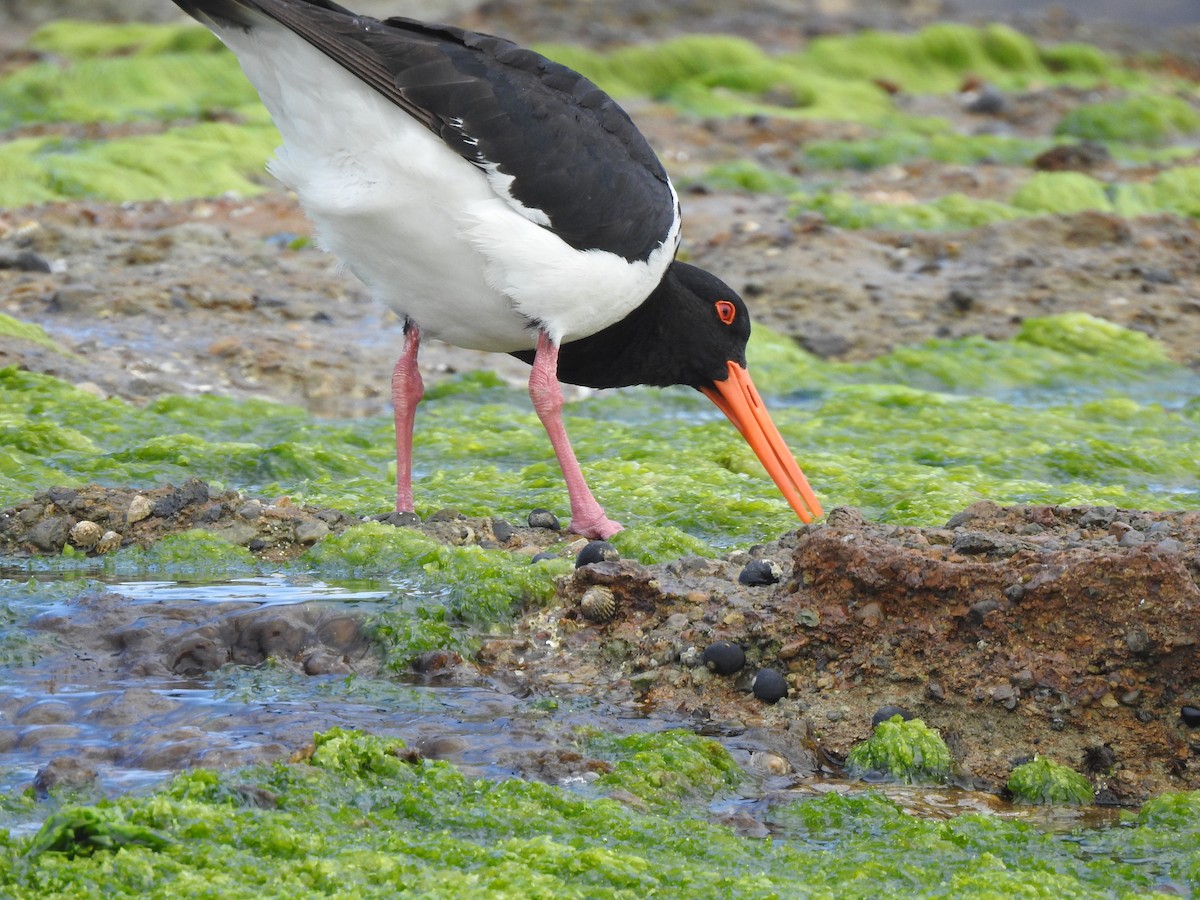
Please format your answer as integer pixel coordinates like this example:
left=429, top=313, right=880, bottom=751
left=0, top=314, right=1200, bottom=549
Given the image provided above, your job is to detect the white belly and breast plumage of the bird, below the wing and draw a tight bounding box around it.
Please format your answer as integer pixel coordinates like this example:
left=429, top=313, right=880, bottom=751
left=206, top=22, right=679, bottom=350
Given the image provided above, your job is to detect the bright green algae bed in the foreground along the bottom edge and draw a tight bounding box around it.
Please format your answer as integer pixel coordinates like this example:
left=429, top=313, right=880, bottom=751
left=0, top=730, right=1200, bottom=899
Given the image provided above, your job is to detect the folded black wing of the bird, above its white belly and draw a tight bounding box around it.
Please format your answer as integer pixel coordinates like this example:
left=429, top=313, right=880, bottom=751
left=175, top=0, right=678, bottom=260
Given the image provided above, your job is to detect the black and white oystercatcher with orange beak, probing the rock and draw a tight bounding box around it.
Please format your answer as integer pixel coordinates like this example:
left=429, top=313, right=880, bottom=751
left=175, top=0, right=821, bottom=538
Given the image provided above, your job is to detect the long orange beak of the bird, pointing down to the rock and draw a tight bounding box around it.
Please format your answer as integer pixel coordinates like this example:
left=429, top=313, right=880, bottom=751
left=700, top=361, right=823, bottom=522
